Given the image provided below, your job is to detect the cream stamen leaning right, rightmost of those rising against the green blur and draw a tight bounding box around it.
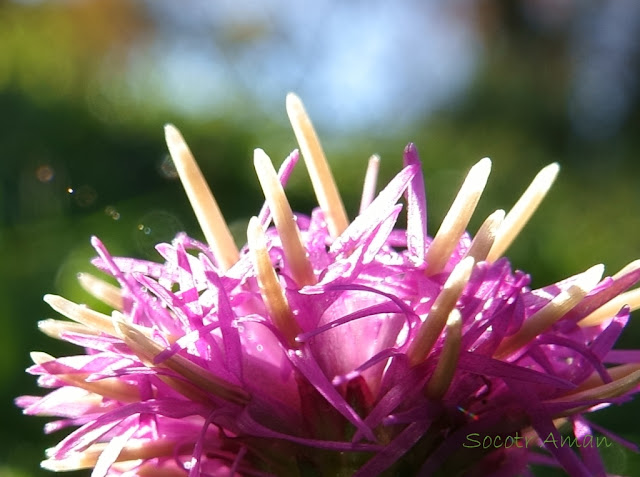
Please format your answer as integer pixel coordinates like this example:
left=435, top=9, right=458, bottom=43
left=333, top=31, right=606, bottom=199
left=487, top=162, right=560, bottom=262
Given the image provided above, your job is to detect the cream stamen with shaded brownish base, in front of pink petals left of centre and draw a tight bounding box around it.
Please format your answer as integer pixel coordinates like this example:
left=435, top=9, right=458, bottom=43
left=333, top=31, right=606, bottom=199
left=247, top=217, right=300, bottom=347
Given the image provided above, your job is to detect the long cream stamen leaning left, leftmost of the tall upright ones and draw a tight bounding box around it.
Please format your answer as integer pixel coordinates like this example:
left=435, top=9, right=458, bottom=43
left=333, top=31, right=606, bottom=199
left=164, top=124, right=239, bottom=271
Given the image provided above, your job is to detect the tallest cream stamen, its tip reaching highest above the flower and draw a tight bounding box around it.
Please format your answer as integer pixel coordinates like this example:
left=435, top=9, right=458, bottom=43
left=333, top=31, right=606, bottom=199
left=286, top=93, right=349, bottom=238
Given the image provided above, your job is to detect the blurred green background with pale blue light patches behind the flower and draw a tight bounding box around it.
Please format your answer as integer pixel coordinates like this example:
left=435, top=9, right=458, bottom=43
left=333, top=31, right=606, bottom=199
left=0, top=0, right=640, bottom=477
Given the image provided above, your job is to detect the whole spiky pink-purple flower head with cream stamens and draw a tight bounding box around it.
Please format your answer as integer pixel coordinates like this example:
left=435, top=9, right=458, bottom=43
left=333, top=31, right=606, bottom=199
left=17, top=95, right=640, bottom=477
